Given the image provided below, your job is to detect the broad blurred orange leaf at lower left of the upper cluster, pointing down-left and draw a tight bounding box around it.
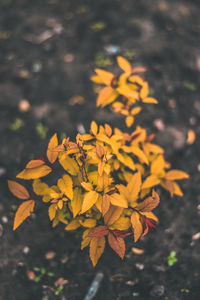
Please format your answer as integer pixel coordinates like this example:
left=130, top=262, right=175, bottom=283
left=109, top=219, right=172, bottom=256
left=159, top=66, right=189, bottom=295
left=97, top=86, right=118, bottom=107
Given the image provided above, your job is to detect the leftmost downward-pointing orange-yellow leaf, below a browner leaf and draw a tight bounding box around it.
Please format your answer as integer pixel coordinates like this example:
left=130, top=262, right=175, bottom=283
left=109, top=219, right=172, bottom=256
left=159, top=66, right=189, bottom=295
left=13, top=200, right=35, bottom=230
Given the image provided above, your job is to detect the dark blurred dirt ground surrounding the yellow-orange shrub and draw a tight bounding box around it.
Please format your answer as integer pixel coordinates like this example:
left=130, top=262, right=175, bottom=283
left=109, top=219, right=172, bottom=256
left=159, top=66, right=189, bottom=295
left=0, top=0, right=200, bottom=300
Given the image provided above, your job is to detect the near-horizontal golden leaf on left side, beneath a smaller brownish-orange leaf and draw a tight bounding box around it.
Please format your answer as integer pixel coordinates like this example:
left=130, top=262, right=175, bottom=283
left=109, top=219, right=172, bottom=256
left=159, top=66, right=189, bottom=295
left=17, top=165, right=52, bottom=180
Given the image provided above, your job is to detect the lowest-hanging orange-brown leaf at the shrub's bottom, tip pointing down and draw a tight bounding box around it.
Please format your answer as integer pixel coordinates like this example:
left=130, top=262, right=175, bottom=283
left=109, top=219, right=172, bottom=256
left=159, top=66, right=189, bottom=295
left=90, top=236, right=105, bottom=267
